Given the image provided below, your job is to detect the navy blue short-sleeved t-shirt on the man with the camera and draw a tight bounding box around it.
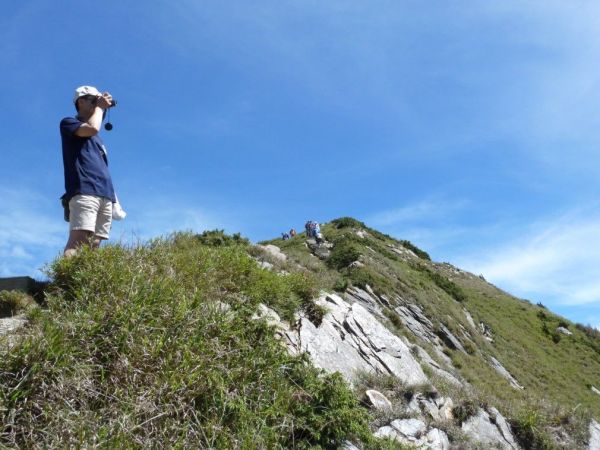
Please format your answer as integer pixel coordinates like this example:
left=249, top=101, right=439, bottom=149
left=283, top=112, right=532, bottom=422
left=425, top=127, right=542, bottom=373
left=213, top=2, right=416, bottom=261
left=60, top=117, right=116, bottom=202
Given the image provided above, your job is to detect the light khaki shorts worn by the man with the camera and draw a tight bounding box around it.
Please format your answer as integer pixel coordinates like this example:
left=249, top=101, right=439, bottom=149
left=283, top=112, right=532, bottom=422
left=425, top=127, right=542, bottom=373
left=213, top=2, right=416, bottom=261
left=69, top=194, right=112, bottom=239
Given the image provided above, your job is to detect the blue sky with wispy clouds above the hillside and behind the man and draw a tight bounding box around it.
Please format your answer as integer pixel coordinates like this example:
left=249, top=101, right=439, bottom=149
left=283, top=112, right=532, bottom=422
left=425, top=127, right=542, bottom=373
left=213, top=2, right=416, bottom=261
left=0, top=0, right=600, bottom=326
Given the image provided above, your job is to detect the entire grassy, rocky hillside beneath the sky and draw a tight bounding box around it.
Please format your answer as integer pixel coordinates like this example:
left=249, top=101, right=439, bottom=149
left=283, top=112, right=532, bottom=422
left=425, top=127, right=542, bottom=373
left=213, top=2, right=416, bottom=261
left=0, top=218, right=600, bottom=448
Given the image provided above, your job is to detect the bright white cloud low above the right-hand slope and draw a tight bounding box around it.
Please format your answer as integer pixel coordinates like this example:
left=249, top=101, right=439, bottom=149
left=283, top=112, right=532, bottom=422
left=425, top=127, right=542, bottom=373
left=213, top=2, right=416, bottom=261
left=459, top=209, right=600, bottom=305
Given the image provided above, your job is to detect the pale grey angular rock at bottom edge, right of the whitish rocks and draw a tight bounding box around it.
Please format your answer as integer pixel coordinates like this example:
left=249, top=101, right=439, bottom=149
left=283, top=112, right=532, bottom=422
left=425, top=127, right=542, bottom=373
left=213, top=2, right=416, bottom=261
left=462, top=408, right=519, bottom=450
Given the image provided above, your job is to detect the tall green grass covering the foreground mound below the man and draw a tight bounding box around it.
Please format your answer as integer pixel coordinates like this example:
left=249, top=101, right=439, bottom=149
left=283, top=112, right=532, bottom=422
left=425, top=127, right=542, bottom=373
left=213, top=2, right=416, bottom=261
left=0, top=234, right=390, bottom=449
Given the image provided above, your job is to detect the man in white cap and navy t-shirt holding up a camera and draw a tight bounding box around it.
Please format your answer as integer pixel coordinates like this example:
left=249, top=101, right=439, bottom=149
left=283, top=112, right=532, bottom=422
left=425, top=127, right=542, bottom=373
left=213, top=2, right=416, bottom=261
left=60, top=86, right=116, bottom=257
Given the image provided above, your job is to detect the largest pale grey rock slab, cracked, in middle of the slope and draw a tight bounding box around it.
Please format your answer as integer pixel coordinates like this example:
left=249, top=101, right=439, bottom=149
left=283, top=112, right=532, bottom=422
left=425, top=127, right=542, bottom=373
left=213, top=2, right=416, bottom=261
left=285, top=294, right=428, bottom=385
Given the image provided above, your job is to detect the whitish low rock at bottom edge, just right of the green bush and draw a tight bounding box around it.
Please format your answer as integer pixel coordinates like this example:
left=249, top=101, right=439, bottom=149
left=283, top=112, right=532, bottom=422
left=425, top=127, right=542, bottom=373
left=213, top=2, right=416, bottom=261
left=375, top=419, right=450, bottom=450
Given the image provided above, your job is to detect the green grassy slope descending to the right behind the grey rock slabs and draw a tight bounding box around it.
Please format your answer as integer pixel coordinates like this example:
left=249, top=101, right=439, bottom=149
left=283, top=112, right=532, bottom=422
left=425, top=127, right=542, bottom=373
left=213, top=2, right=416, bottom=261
left=262, top=219, right=600, bottom=445
